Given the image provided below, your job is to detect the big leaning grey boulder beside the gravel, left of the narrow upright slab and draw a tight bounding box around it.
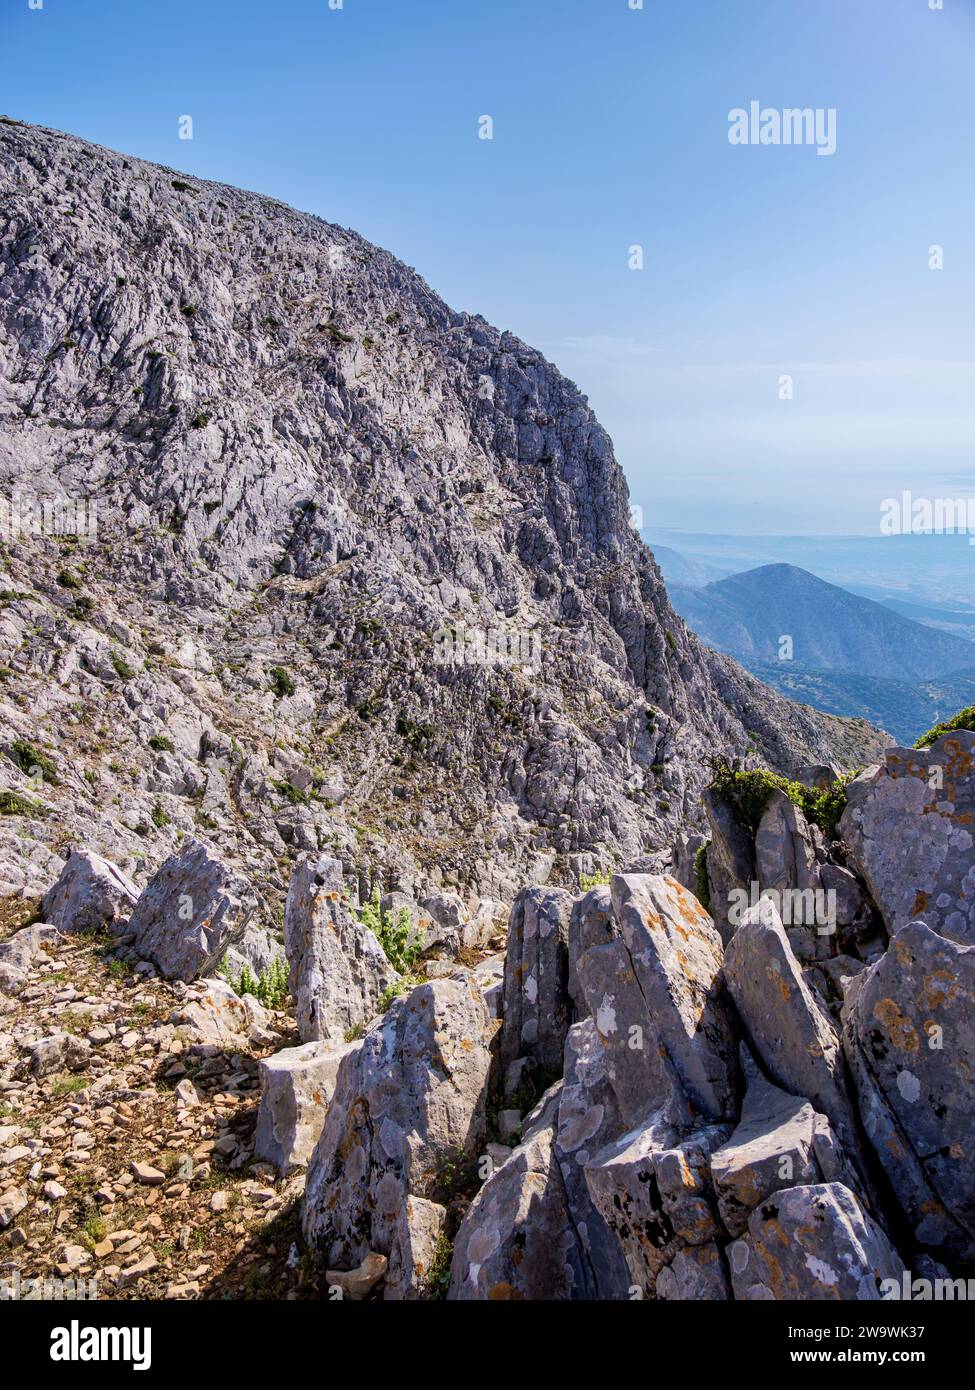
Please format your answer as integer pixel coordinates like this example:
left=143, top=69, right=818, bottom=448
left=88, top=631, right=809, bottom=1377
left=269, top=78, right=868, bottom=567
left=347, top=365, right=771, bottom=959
left=302, top=972, right=495, bottom=1297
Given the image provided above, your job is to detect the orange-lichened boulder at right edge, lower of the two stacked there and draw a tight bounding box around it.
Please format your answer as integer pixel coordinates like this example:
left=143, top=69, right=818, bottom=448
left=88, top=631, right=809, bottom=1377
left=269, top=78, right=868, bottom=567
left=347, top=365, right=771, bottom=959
left=843, top=922, right=975, bottom=1261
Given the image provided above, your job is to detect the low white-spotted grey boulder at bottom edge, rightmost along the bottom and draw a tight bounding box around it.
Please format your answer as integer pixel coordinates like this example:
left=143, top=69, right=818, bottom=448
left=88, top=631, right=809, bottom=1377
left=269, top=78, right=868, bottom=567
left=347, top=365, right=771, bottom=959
left=727, top=1183, right=905, bottom=1301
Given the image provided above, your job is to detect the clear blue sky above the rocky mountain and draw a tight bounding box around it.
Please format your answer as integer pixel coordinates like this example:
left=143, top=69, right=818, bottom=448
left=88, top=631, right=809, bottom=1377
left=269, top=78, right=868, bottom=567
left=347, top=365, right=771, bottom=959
left=0, top=0, right=975, bottom=535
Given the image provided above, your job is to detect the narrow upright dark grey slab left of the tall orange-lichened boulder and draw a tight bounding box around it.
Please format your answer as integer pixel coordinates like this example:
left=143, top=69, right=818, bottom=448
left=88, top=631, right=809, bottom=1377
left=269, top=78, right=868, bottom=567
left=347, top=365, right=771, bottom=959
left=501, top=888, right=572, bottom=1076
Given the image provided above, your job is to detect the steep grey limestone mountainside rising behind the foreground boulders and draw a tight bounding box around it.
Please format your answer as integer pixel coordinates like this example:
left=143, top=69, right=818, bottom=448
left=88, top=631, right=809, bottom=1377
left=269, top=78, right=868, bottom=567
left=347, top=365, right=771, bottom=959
left=0, top=121, right=878, bottom=897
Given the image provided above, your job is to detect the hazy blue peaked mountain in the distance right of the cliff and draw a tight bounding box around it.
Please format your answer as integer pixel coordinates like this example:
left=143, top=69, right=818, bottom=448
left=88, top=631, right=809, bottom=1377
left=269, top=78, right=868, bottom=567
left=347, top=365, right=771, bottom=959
left=669, top=564, right=975, bottom=683
